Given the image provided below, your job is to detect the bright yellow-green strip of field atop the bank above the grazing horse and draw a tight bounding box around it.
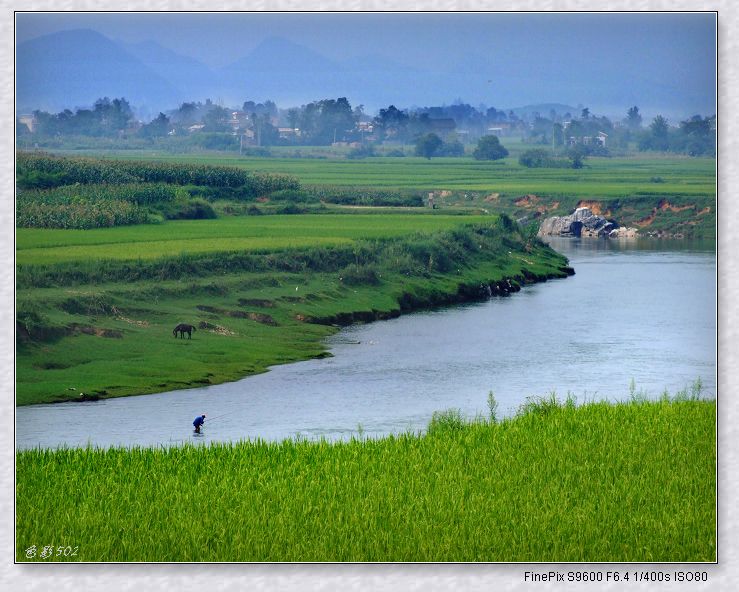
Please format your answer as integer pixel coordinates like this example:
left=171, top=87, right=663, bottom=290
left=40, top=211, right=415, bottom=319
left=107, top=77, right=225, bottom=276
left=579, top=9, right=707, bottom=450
left=16, top=214, right=491, bottom=265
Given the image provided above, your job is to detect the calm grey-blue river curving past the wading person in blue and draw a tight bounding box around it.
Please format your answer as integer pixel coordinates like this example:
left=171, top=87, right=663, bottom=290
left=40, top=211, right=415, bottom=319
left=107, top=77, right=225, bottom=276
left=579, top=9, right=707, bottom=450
left=16, top=239, right=716, bottom=448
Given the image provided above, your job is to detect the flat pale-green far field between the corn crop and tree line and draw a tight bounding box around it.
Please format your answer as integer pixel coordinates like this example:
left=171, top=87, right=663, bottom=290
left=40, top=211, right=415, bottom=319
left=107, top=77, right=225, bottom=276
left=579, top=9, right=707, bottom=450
left=85, top=151, right=716, bottom=199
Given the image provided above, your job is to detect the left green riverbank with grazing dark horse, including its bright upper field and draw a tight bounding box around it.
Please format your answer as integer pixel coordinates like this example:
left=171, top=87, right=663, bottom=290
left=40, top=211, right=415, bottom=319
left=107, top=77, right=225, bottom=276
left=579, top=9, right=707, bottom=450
left=16, top=214, right=567, bottom=405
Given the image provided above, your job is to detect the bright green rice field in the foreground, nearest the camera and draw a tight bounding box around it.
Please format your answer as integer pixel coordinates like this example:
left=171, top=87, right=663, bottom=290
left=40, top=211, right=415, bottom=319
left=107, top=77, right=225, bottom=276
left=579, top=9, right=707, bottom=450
left=16, top=396, right=716, bottom=562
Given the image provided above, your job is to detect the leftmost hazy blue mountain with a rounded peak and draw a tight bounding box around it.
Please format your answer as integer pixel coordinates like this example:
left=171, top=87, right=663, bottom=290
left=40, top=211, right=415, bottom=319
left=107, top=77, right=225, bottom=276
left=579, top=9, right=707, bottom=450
left=16, top=29, right=180, bottom=111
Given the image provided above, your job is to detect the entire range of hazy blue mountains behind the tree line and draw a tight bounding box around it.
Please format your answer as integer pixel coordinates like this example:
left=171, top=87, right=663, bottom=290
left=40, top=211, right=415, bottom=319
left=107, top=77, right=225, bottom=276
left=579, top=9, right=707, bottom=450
left=16, top=29, right=704, bottom=119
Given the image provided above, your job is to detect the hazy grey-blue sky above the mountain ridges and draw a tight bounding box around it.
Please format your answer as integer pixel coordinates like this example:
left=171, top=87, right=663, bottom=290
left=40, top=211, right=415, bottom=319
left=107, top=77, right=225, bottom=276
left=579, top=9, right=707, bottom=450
left=16, top=12, right=715, bottom=67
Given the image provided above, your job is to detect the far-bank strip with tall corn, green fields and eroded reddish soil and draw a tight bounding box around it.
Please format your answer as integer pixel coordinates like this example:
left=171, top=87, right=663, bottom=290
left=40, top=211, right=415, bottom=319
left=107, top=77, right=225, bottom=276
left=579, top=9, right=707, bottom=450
left=16, top=142, right=716, bottom=238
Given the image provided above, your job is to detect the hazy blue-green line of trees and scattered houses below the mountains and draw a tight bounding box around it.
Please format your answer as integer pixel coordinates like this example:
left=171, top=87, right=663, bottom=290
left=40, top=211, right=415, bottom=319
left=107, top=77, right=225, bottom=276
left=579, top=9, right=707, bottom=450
left=16, top=97, right=716, bottom=157
